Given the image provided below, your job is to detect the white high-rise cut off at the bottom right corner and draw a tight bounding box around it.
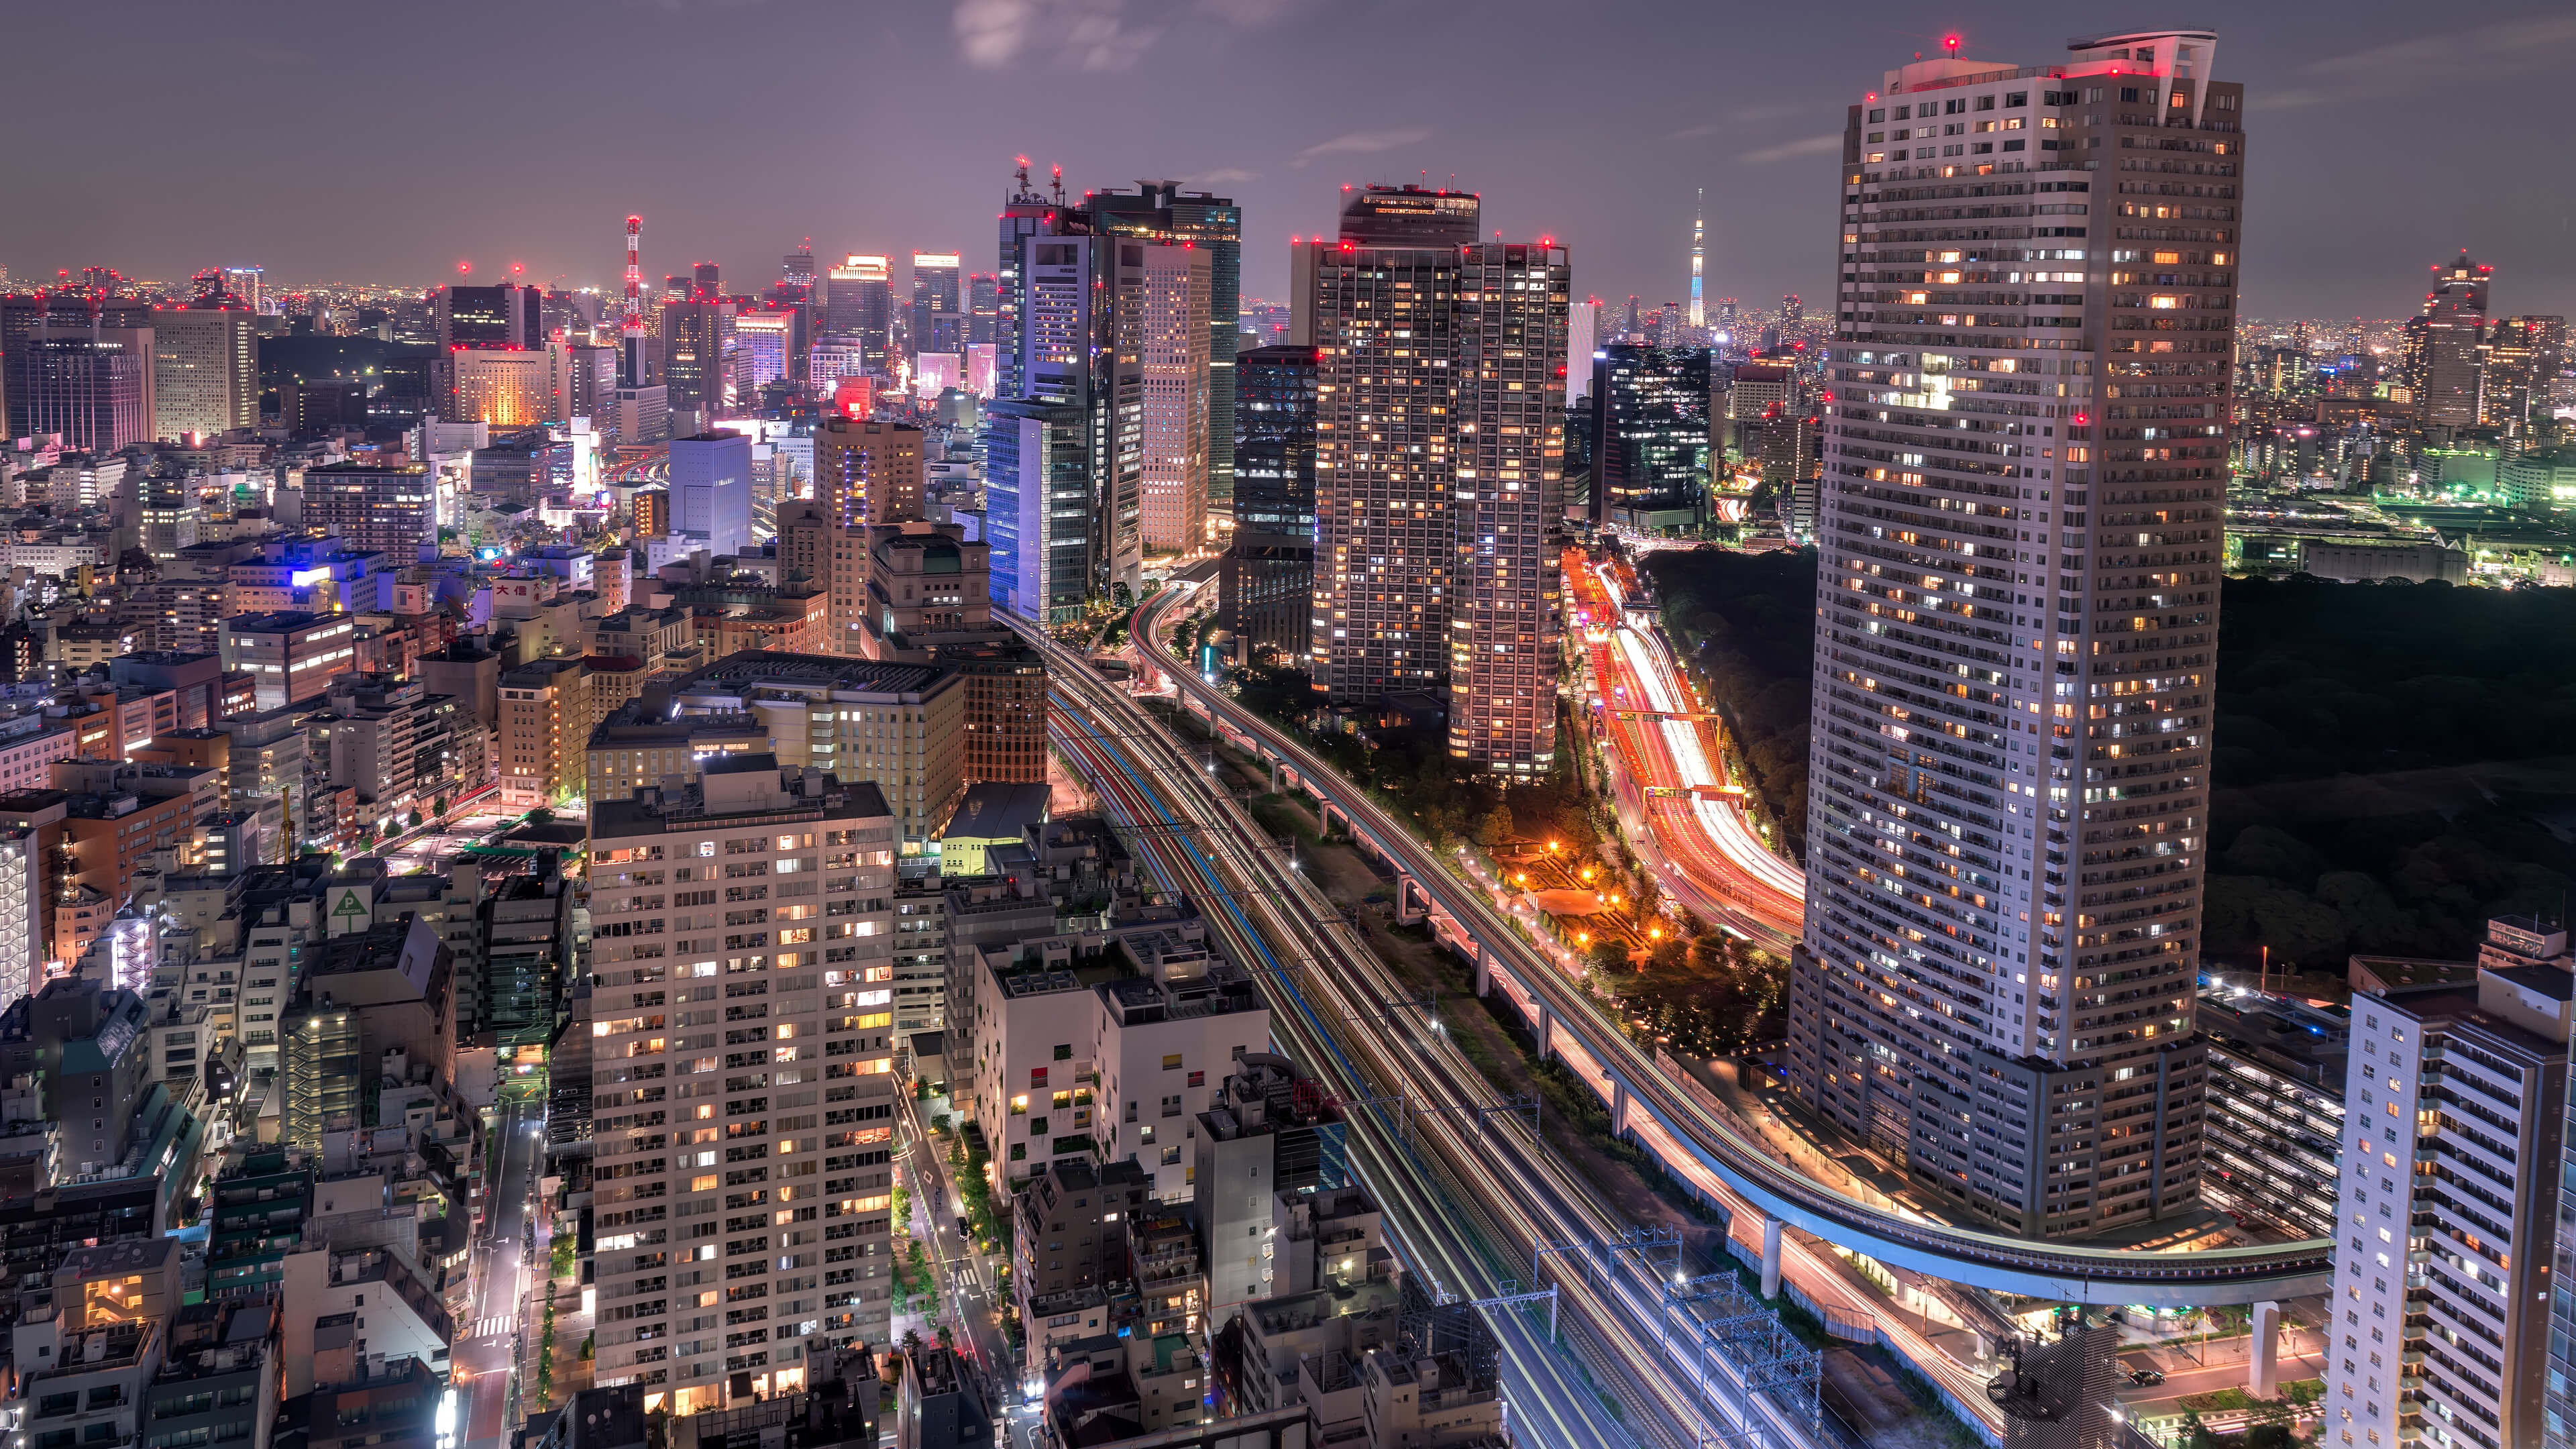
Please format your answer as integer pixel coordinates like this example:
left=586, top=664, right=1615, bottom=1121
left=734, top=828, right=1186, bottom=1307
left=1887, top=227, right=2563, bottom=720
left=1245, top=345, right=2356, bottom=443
left=2321, top=918, right=2576, bottom=1449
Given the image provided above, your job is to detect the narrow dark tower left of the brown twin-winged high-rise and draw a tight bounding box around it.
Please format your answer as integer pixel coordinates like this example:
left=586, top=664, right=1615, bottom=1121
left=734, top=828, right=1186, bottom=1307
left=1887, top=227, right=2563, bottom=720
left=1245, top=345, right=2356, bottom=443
left=1216, top=345, right=1316, bottom=663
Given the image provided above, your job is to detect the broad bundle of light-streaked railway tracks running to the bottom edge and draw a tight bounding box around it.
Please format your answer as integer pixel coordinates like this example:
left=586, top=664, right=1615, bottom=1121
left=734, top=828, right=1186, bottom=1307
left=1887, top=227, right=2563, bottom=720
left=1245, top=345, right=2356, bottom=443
left=1046, top=626, right=1813, bottom=1449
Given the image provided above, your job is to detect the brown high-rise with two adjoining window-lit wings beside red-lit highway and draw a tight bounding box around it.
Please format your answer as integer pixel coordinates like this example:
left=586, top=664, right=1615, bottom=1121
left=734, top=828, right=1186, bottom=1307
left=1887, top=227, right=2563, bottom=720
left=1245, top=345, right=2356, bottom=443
left=1291, top=186, right=1566, bottom=779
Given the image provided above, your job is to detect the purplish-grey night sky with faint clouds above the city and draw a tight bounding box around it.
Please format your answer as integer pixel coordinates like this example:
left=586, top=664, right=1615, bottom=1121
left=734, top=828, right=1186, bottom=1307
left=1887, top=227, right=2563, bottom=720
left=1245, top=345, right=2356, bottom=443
left=15, top=0, right=2576, bottom=317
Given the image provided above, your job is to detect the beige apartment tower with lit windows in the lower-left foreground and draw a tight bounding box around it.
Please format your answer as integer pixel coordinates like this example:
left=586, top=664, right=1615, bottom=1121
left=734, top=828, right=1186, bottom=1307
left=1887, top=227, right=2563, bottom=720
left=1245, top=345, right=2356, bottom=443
left=590, top=755, right=896, bottom=1413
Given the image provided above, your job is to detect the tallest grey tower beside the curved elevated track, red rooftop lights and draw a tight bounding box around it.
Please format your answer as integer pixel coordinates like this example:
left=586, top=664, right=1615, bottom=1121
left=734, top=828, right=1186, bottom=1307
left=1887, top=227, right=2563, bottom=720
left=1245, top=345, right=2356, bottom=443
left=1788, top=31, right=2244, bottom=1238
